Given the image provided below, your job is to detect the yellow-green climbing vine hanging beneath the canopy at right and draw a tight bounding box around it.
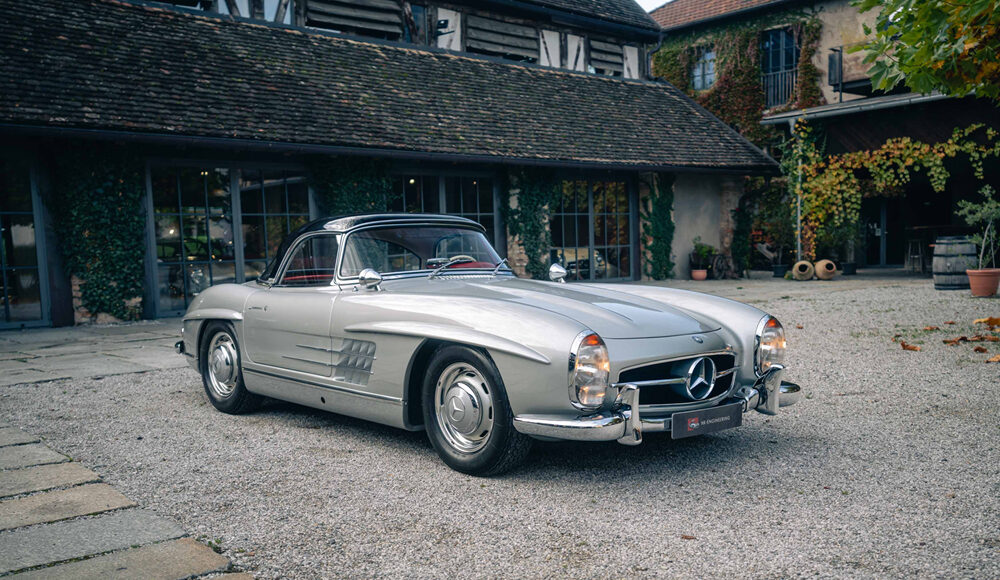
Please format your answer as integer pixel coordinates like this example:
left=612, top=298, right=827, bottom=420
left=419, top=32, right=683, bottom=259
left=783, top=121, right=1000, bottom=259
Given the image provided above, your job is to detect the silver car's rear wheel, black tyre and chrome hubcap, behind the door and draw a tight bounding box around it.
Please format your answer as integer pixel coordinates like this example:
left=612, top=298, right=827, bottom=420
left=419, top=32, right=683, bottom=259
left=198, top=321, right=261, bottom=415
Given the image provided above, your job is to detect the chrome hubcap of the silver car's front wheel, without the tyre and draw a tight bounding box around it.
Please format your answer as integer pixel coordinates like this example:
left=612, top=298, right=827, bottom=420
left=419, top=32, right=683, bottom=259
left=434, top=363, right=493, bottom=453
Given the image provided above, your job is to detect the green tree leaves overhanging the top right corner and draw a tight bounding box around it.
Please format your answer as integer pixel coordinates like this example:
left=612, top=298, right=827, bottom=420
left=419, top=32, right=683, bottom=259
left=854, top=0, right=1000, bottom=102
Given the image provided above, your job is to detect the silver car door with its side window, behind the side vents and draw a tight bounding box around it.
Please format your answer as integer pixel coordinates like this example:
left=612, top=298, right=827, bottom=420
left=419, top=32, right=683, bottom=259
left=243, top=234, right=340, bottom=377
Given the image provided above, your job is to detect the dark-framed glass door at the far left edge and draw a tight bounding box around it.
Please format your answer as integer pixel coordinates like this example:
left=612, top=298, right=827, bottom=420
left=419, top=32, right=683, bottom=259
left=0, top=159, right=48, bottom=328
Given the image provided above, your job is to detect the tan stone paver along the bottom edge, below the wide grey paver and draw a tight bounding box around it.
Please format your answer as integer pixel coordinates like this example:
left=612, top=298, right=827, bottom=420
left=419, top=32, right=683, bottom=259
left=13, top=538, right=230, bottom=580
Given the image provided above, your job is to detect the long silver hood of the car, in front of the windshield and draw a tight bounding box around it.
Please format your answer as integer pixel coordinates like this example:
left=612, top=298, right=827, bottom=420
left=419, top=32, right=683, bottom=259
left=384, top=274, right=719, bottom=339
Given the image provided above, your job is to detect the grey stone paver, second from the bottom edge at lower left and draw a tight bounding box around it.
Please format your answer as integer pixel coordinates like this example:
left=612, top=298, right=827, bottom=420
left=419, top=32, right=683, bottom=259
left=0, top=509, right=184, bottom=574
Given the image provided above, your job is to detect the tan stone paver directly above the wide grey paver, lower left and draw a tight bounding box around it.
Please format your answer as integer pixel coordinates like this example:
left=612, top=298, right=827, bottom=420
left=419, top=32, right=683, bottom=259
left=0, top=483, right=136, bottom=530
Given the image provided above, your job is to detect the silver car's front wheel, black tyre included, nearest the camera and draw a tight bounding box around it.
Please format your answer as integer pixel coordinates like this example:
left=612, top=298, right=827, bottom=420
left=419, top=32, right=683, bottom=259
left=423, top=345, right=532, bottom=475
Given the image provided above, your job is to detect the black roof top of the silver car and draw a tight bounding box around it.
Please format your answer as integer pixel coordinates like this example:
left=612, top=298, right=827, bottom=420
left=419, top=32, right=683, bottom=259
left=259, top=213, right=486, bottom=280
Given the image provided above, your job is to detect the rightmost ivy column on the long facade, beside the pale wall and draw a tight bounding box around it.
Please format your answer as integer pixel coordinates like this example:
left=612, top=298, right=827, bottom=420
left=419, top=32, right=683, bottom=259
left=639, top=173, right=674, bottom=280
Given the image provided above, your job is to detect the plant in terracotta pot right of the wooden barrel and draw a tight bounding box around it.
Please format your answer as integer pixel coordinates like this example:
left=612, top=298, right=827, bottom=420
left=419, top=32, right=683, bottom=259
left=955, top=185, right=1000, bottom=296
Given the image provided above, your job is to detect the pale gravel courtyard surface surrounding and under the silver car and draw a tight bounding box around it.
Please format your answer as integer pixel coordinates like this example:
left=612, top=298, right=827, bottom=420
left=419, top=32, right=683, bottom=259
left=0, top=278, right=1000, bottom=578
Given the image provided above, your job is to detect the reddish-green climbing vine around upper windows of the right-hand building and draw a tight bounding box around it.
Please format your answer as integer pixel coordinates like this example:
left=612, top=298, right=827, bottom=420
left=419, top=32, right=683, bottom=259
left=653, top=13, right=823, bottom=145
